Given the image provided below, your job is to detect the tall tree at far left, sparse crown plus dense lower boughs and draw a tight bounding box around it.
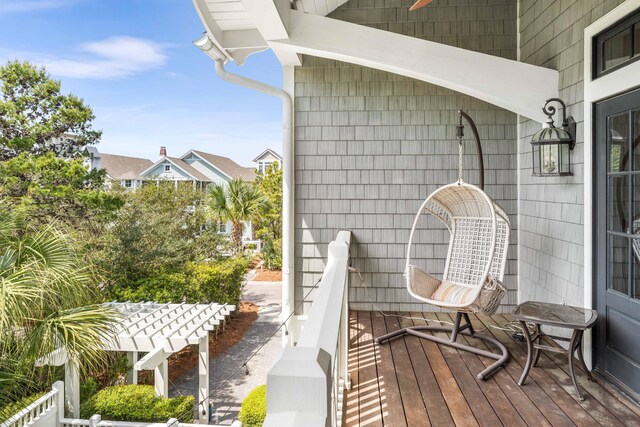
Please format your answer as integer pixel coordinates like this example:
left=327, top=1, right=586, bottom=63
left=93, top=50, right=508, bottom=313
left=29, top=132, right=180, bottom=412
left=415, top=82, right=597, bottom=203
left=0, top=61, right=121, bottom=234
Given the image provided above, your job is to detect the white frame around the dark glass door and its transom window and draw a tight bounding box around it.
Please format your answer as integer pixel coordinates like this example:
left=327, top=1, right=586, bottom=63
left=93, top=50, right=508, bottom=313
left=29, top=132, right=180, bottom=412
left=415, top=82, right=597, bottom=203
left=584, top=0, right=640, bottom=367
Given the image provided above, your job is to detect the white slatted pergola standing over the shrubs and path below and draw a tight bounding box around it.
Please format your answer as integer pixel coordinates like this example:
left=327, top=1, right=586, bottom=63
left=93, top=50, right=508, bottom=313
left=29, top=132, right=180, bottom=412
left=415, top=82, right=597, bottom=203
left=38, top=302, right=235, bottom=421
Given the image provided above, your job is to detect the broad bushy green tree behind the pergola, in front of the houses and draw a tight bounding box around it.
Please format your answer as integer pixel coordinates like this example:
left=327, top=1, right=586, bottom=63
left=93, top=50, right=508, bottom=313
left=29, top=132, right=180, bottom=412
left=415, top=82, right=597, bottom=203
left=95, top=182, right=221, bottom=288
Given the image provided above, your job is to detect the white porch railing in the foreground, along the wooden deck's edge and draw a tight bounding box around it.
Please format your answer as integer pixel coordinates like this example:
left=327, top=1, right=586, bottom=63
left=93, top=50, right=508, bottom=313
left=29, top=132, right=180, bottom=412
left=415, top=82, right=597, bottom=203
left=264, top=231, right=351, bottom=427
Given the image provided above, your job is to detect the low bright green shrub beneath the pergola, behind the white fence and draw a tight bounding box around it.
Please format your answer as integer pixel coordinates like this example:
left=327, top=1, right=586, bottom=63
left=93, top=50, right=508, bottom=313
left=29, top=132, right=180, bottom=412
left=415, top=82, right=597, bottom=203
left=80, top=384, right=195, bottom=422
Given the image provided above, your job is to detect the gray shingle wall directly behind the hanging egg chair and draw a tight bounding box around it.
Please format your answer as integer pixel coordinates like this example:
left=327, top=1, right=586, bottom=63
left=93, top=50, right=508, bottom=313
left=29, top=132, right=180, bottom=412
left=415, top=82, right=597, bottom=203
left=295, top=0, right=517, bottom=311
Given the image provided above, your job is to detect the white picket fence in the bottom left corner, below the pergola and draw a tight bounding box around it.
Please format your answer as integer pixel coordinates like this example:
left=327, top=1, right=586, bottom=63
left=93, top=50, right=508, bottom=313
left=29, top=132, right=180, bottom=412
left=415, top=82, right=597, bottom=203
left=0, top=381, right=235, bottom=427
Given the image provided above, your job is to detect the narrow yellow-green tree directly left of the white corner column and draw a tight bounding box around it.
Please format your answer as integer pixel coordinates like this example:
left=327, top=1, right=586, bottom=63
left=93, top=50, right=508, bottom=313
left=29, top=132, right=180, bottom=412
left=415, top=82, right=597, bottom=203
left=256, top=163, right=282, bottom=269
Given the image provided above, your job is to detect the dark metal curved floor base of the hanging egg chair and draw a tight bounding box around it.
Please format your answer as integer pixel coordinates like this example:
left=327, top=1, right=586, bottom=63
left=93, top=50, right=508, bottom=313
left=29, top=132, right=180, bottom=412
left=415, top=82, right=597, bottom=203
left=376, top=312, right=509, bottom=380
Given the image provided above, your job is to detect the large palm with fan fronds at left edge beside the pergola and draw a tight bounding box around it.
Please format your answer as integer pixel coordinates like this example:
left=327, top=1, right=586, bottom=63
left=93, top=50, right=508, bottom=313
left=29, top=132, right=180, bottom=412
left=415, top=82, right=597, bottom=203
left=0, top=210, right=118, bottom=419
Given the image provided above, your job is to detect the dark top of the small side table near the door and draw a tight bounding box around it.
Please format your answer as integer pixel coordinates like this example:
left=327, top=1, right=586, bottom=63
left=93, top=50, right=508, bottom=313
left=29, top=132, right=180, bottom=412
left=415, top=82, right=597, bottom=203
left=512, top=301, right=598, bottom=329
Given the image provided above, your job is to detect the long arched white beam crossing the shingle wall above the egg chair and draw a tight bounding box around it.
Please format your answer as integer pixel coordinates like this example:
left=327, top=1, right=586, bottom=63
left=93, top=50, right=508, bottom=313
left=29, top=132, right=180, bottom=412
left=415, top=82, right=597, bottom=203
left=272, top=10, right=559, bottom=123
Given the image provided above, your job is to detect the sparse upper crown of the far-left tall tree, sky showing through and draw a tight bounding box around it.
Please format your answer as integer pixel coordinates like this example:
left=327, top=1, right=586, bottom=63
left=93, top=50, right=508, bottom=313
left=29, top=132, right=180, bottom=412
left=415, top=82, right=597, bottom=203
left=0, top=61, right=101, bottom=160
